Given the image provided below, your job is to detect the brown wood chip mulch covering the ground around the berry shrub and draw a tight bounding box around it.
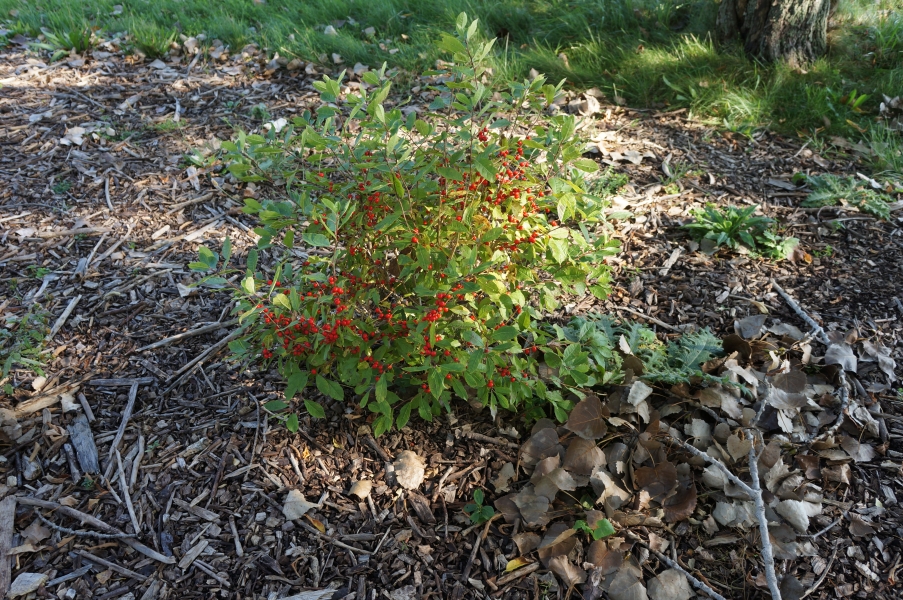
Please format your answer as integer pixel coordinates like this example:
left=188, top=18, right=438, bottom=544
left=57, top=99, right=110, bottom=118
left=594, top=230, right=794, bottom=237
left=0, top=39, right=903, bottom=600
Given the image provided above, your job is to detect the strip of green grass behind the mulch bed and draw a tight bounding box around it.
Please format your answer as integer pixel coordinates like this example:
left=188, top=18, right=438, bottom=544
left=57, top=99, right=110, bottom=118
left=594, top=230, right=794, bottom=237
left=0, top=0, right=903, bottom=174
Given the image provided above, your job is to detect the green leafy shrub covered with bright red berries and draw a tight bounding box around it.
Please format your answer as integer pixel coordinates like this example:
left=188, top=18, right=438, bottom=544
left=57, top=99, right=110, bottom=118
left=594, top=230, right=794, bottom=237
left=192, top=14, right=618, bottom=434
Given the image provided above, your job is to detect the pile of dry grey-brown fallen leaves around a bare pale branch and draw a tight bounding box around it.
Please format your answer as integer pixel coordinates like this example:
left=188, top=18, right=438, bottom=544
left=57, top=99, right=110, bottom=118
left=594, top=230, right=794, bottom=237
left=494, top=315, right=900, bottom=600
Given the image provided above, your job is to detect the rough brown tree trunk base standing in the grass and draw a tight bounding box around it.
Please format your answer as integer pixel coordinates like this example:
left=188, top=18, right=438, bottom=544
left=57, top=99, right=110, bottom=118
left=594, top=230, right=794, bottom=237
left=715, top=0, right=831, bottom=66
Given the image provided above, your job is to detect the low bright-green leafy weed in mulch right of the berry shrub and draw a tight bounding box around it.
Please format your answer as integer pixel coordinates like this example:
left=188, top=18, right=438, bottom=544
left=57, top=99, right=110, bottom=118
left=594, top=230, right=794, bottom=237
left=684, top=204, right=799, bottom=260
